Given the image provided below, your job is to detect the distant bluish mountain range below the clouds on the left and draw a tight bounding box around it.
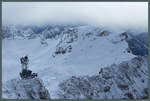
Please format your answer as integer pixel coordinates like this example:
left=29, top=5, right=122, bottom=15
left=2, top=25, right=77, bottom=39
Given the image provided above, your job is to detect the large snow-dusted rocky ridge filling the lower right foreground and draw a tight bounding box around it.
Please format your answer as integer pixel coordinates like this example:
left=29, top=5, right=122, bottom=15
left=58, top=57, right=148, bottom=99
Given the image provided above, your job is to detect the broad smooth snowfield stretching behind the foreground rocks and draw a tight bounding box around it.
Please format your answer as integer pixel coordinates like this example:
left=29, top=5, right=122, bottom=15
left=2, top=26, right=135, bottom=99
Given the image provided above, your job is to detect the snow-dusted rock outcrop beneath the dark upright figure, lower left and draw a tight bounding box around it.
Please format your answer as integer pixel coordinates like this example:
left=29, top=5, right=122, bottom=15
left=2, top=78, right=50, bottom=99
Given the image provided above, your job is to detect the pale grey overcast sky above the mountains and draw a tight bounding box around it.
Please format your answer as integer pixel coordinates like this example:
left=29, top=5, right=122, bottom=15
left=2, top=2, right=148, bottom=28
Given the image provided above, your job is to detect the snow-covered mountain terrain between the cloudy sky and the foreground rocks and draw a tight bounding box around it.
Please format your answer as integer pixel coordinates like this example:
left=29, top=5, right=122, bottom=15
left=2, top=25, right=148, bottom=99
